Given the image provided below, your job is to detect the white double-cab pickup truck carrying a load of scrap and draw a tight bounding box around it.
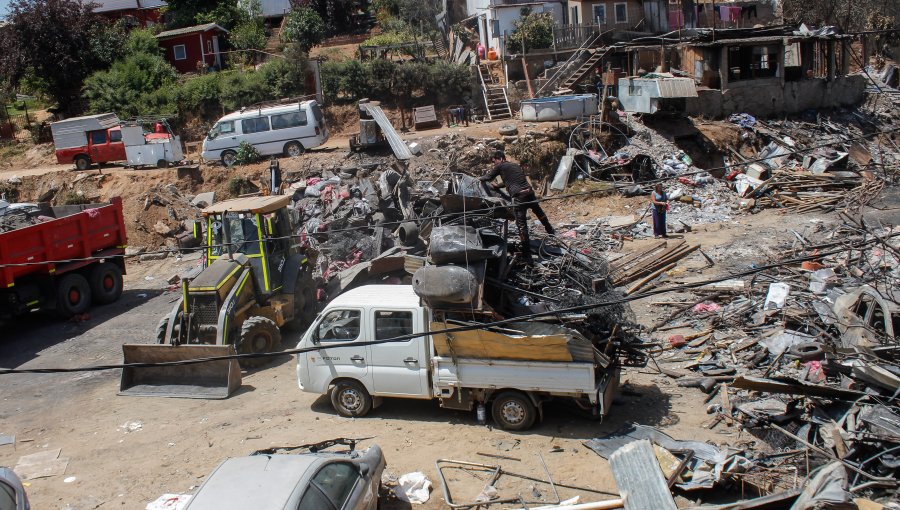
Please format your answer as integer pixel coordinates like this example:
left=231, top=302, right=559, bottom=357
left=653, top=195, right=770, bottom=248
left=297, top=285, right=619, bottom=430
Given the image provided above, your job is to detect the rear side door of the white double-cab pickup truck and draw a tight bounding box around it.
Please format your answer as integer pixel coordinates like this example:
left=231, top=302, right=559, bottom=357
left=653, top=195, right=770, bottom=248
left=370, top=308, right=430, bottom=398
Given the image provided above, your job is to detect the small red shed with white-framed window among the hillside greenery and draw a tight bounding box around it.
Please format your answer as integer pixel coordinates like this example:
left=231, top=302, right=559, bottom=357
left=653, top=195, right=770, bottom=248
left=156, top=23, right=228, bottom=73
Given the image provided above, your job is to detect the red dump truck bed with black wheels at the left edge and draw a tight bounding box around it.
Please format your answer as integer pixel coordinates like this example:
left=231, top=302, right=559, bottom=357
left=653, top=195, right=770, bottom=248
left=0, top=197, right=126, bottom=318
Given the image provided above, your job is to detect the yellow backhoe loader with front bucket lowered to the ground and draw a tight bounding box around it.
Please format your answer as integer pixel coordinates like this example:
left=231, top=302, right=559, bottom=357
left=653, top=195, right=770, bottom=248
left=119, top=195, right=317, bottom=398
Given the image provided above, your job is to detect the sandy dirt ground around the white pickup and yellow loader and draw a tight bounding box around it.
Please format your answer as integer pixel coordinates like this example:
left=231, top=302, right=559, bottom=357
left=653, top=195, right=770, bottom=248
left=0, top=205, right=813, bottom=510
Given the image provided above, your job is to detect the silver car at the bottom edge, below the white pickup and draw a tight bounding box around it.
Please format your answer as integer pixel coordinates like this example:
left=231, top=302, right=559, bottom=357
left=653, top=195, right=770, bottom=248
left=185, top=440, right=385, bottom=510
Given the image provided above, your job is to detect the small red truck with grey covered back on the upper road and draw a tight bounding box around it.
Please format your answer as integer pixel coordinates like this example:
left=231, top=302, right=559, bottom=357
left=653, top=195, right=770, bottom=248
left=50, top=113, right=127, bottom=170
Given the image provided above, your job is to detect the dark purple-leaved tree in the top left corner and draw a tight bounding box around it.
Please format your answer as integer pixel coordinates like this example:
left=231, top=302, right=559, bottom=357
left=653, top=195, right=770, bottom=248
left=0, top=0, right=117, bottom=107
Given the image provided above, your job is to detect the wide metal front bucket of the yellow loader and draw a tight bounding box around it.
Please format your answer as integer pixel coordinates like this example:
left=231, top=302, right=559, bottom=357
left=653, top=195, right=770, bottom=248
left=119, top=344, right=241, bottom=399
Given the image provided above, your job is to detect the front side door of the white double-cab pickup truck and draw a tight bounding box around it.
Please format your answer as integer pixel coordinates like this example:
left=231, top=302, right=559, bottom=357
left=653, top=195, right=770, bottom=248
left=305, top=308, right=372, bottom=389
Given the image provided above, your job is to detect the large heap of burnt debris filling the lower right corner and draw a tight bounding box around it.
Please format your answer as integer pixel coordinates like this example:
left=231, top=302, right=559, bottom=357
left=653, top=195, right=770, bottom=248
left=640, top=219, right=900, bottom=508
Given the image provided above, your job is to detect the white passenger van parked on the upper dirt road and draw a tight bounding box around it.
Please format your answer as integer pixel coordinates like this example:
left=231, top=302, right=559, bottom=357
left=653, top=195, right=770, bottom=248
left=201, top=100, right=328, bottom=166
